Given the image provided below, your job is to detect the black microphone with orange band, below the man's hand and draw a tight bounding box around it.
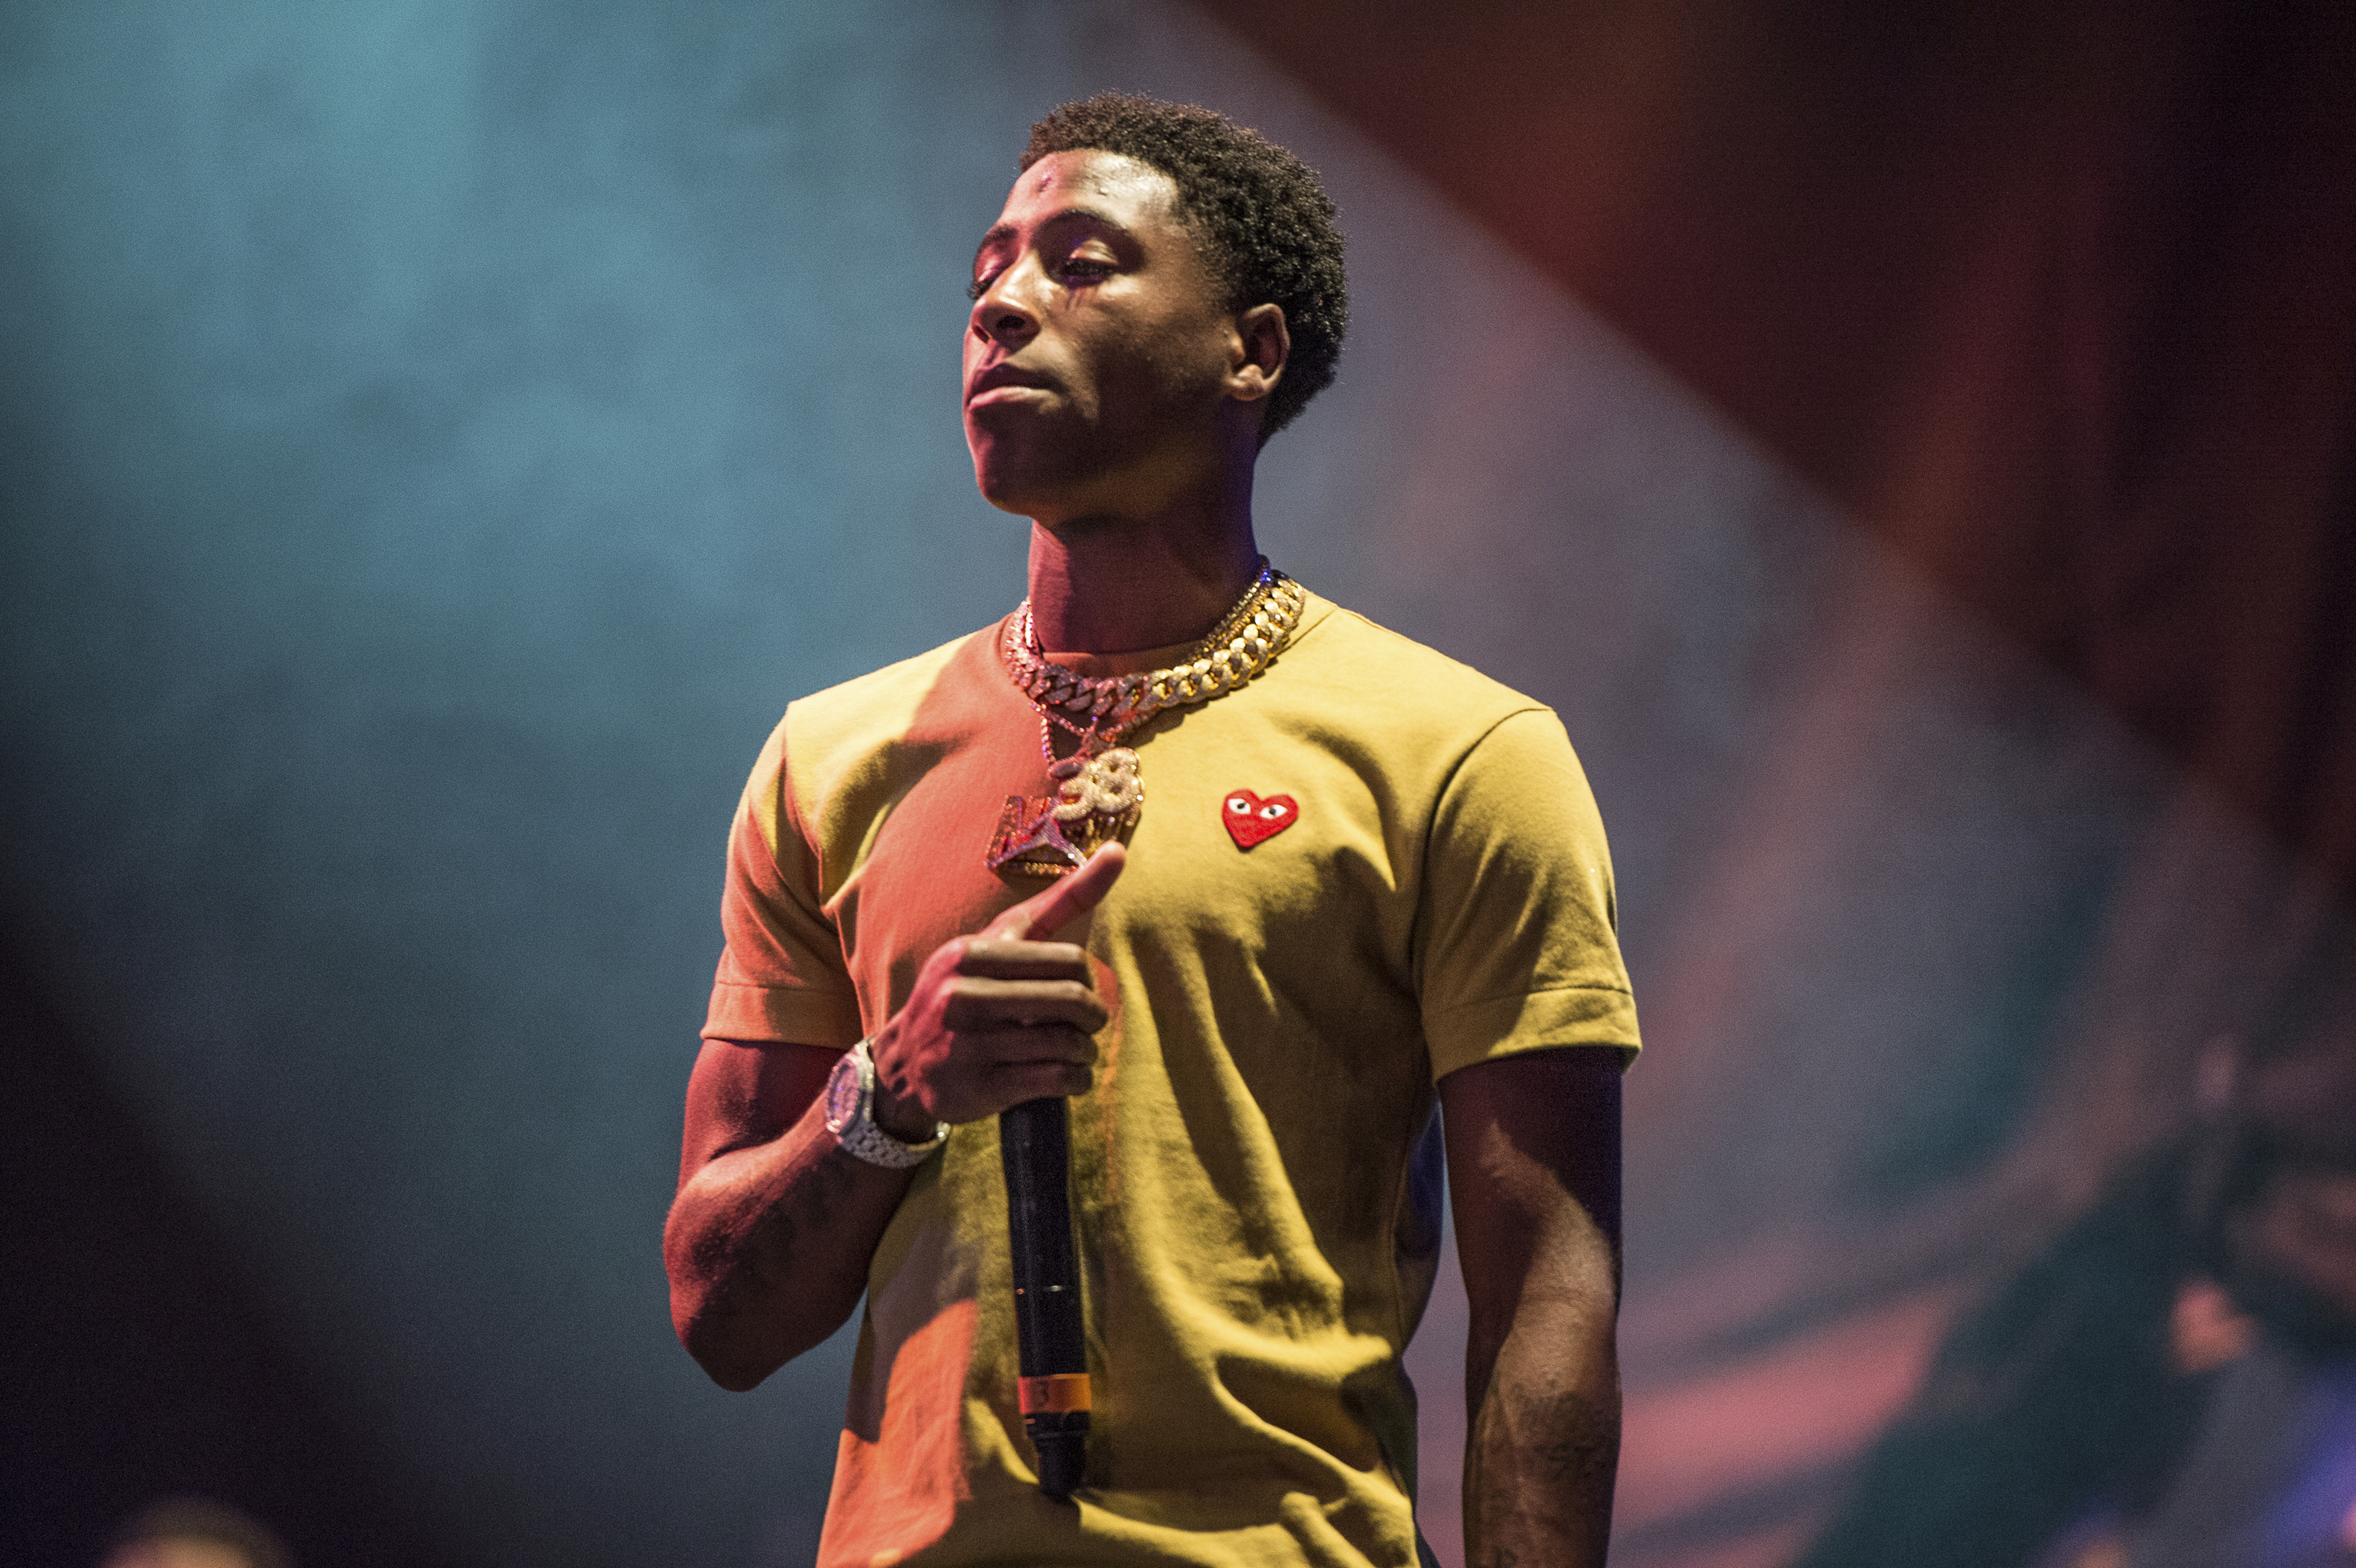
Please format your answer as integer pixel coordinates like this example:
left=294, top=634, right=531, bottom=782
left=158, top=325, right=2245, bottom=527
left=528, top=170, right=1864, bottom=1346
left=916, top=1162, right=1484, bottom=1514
left=999, top=1097, right=1091, bottom=1502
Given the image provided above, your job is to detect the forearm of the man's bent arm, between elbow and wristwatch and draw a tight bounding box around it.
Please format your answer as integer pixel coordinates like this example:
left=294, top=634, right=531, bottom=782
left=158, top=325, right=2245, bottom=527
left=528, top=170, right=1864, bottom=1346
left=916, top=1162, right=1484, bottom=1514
left=662, top=1104, right=912, bottom=1389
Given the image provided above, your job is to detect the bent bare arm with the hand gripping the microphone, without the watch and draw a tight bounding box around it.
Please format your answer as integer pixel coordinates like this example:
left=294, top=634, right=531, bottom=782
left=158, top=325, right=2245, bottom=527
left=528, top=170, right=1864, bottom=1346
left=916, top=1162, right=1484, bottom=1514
left=662, top=845, right=1121, bottom=1389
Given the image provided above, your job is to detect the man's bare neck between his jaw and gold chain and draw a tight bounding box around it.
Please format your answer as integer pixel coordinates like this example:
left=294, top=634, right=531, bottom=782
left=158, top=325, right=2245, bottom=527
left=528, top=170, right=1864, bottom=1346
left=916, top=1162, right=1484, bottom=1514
left=1030, top=469, right=1261, bottom=655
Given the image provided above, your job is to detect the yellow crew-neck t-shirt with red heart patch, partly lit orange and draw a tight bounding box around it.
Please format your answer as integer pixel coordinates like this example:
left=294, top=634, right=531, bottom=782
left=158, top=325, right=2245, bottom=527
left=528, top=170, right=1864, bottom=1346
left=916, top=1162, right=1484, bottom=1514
left=704, top=595, right=1637, bottom=1568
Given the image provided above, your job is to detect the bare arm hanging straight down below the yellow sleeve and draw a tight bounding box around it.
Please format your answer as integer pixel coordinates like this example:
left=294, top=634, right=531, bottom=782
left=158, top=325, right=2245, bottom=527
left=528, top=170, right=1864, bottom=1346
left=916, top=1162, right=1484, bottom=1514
left=1439, top=1048, right=1621, bottom=1568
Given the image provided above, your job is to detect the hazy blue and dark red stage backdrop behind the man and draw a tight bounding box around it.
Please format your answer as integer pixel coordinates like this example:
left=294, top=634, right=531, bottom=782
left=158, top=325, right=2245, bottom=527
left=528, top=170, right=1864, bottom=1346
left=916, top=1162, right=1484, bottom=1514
left=0, top=0, right=2356, bottom=1568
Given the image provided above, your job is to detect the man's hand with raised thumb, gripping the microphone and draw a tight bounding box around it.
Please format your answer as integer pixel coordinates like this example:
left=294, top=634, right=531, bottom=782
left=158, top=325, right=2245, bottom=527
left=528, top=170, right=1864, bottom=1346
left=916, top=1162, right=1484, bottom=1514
left=867, top=843, right=1126, bottom=1142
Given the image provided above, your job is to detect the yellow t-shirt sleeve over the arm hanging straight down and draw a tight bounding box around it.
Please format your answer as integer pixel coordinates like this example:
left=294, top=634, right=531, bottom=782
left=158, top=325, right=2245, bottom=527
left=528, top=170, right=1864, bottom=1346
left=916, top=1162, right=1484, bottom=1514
left=1416, top=708, right=1637, bottom=1078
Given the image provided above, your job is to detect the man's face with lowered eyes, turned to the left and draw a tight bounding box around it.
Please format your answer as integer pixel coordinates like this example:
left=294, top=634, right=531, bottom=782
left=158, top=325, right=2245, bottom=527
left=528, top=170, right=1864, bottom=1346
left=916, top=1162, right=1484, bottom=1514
left=966, top=151, right=1241, bottom=525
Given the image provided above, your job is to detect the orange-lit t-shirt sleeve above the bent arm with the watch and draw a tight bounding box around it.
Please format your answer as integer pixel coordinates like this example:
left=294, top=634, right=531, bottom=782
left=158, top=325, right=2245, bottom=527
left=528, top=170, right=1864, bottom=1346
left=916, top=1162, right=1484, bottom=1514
left=704, top=723, right=860, bottom=1050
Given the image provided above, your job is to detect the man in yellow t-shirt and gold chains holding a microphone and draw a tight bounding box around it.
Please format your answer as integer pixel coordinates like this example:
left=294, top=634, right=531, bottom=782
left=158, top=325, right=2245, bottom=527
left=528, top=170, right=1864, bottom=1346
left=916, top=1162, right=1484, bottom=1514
left=667, top=95, right=1635, bottom=1568
